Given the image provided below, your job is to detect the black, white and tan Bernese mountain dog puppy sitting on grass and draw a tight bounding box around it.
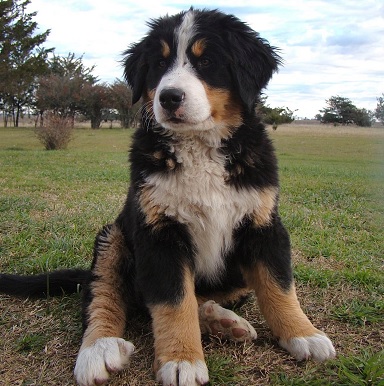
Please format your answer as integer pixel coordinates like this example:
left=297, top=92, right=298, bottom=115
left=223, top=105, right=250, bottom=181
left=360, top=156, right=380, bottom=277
left=0, top=8, right=335, bottom=386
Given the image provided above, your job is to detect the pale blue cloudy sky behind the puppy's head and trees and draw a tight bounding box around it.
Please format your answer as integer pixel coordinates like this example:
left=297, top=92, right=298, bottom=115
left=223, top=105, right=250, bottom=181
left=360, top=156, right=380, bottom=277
left=28, top=0, right=384, bottom=118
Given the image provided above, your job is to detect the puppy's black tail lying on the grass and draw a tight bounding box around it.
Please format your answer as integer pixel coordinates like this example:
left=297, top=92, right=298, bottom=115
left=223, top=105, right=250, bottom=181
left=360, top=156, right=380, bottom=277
left=0, top=269, right=91, bottom=298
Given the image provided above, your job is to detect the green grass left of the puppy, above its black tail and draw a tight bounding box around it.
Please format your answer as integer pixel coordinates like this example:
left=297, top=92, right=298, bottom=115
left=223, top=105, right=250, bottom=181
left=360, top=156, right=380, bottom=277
left=0, top=129, right=130, bottom=273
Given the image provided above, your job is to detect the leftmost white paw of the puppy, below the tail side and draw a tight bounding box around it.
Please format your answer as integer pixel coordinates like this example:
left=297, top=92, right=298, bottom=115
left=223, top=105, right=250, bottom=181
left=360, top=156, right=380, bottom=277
left=74, top=338, right=135, bottom=386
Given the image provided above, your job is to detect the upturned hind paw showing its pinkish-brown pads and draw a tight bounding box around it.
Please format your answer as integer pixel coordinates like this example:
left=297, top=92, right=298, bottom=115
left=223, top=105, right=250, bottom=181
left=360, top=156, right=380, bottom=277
left=199, top=300, right=257, bottom=342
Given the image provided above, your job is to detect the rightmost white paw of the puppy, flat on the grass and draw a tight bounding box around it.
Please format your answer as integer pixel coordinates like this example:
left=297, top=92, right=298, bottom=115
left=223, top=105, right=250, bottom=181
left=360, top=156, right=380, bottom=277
left=279, top=333, right=336, bottom=362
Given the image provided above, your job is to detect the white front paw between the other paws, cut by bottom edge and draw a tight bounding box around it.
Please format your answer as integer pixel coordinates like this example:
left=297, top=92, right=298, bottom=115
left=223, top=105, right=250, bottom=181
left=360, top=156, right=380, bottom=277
left=156, top=360, right=209, bottom=386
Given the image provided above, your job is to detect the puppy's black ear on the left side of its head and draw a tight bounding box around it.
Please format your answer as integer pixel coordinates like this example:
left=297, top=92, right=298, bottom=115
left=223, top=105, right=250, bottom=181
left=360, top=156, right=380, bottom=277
left=124, top=41, right=148, bottom=104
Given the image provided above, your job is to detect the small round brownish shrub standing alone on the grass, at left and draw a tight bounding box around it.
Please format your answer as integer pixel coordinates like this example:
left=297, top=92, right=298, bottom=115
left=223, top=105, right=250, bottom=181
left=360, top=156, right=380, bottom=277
left=35, top=113, right=73, bottom=150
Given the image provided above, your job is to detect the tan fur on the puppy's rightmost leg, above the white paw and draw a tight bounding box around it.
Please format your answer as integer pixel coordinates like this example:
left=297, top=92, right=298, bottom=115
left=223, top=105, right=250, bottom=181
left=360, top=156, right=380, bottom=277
left=243, top=263, right=319, bottom=340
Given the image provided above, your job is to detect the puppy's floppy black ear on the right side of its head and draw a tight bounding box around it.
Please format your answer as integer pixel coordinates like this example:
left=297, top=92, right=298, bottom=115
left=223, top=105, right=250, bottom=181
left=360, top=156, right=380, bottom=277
left=228, top=23, right=282, bottom=111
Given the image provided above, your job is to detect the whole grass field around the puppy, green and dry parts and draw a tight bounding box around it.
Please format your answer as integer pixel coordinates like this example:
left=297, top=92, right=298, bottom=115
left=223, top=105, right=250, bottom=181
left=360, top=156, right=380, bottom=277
left=0, top=125, right=384, bottom=386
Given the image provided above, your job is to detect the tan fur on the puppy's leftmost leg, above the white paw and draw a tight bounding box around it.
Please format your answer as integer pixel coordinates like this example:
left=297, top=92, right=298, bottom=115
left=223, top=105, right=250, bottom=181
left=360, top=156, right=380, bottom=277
left=81, top=225, right=126, bottom=349
